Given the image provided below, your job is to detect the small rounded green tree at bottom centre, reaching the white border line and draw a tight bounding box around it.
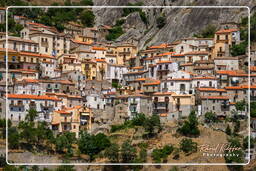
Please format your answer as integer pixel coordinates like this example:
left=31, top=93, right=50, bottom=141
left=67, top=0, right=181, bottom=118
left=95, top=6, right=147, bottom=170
left=121, top=141, right=136, bottom=163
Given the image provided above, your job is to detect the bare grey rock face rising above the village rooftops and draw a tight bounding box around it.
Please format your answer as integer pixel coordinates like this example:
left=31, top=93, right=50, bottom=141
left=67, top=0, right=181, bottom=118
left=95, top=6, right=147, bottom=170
left=93, top=0, right=256, bottom=49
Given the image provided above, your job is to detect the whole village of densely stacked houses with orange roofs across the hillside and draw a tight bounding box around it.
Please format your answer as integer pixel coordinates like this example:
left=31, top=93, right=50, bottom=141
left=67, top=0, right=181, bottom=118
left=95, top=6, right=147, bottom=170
left=0, top=5, right=256, bottom=167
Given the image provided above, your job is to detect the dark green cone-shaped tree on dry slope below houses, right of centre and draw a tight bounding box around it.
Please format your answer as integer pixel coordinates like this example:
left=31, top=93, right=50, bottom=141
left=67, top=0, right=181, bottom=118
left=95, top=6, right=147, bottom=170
left=177, top=111, right=200, bottom=136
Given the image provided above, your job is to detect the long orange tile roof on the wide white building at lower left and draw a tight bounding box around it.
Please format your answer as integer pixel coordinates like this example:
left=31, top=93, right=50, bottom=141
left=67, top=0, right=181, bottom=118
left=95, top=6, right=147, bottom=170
left=7, top=94, right=61, bottom=101
